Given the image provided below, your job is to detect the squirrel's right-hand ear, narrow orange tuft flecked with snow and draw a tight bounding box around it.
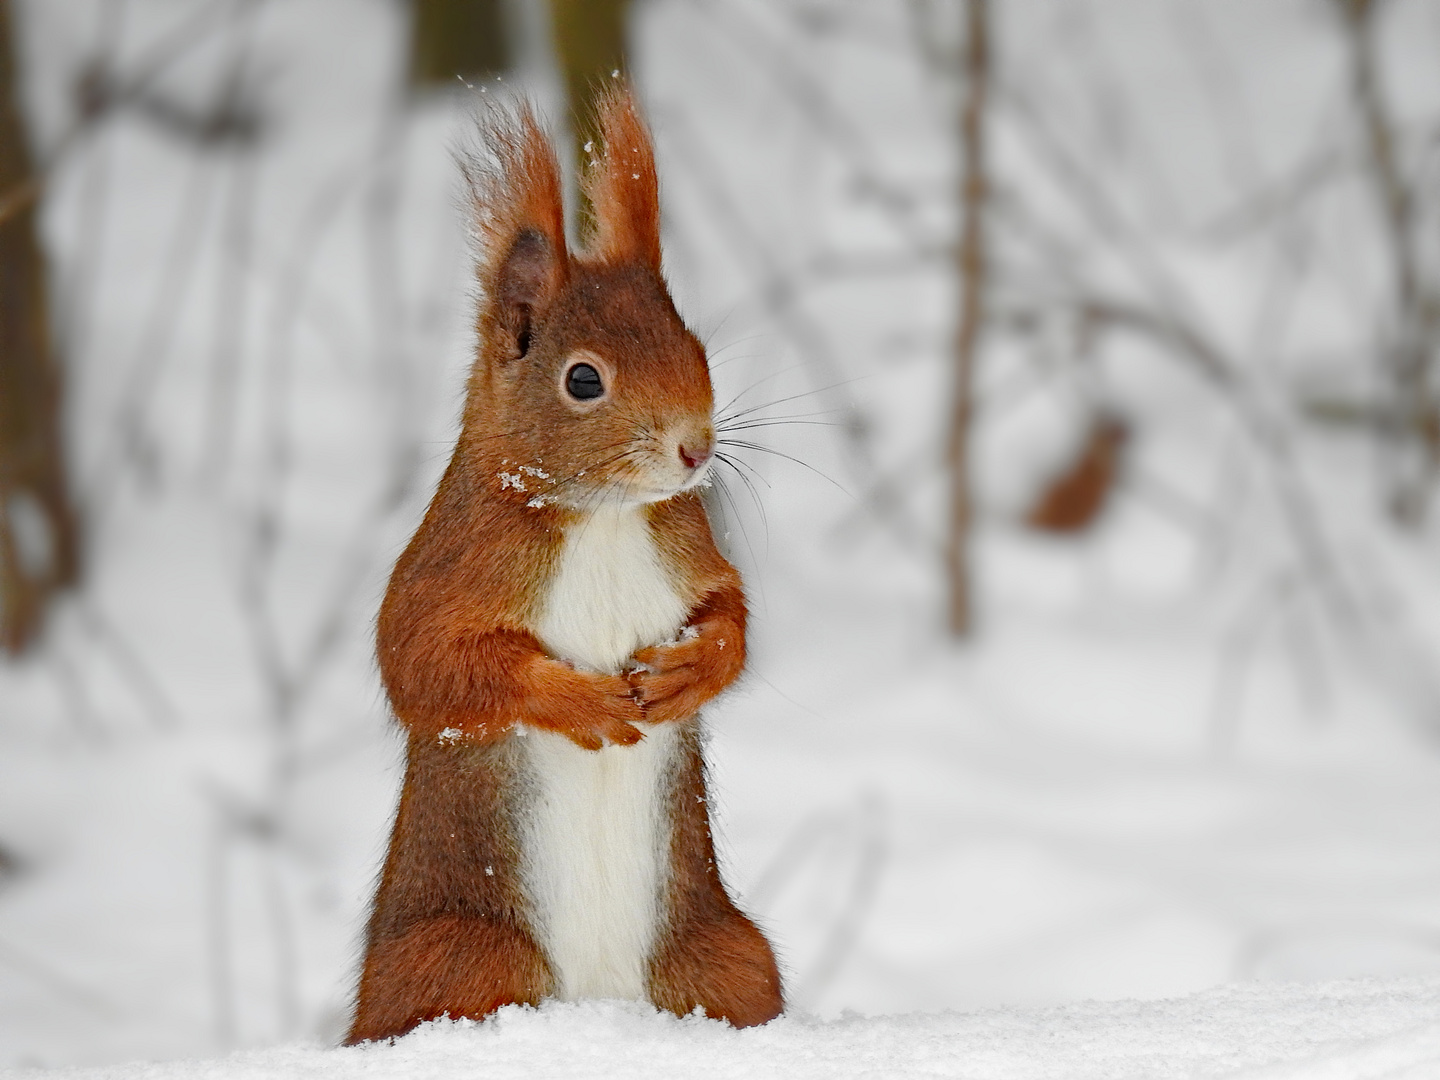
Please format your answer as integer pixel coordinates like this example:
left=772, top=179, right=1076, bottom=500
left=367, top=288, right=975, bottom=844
left=585, top=82, right=660, bottom=272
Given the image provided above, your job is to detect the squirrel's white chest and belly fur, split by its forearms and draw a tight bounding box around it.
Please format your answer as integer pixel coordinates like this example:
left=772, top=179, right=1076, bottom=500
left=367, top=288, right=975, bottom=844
left=524, top=507, right=687, bottom=1001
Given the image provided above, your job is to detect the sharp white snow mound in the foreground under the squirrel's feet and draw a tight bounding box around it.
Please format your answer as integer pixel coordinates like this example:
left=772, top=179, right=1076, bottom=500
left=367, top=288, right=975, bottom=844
left=19, top=979, right=1440, bottom=1080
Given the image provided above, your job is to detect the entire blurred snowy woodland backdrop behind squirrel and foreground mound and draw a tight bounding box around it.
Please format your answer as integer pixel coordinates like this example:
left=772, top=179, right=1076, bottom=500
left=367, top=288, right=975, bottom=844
left=0, top=0, right=1440, bottom=1064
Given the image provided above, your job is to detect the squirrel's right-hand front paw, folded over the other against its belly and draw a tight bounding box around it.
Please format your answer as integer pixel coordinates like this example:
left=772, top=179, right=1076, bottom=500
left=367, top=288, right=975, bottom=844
left=629, top=619, right=744, bottom=723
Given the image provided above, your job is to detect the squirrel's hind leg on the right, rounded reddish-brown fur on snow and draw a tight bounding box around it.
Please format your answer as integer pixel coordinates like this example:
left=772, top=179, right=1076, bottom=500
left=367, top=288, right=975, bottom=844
left=649, top=907, right=785, bottom=1028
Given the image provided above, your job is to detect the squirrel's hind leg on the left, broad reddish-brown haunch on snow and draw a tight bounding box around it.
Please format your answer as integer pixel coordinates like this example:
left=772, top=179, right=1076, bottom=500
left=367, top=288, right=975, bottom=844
left=346, top=914, right=553, bottom=1045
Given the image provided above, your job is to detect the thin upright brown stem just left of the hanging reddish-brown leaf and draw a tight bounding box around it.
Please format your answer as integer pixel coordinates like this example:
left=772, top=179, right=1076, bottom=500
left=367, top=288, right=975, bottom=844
left=945, top=0, right=991, bottom=638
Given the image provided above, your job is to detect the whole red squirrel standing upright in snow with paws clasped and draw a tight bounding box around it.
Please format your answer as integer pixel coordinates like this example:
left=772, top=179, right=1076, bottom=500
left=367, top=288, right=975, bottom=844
left=347, top=88, right=783, bottom=1043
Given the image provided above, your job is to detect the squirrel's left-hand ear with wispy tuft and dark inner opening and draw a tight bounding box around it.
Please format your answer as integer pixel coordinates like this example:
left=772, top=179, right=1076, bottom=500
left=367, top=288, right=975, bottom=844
left=462, top=105, right=569, bottom=360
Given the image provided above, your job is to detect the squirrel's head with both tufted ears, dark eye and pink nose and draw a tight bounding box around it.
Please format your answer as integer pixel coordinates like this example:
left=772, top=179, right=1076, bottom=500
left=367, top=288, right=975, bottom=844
left=461, top=86, right=714, bottom=510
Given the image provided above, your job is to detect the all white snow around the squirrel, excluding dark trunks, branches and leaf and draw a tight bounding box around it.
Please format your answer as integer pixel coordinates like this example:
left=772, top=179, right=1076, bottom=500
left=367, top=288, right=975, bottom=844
left=0, top=0, right=1440, bottom=1077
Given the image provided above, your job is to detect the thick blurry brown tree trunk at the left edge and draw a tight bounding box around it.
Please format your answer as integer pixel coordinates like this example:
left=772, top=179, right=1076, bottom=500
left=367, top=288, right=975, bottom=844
left=0, top=0, right=76, bottom=652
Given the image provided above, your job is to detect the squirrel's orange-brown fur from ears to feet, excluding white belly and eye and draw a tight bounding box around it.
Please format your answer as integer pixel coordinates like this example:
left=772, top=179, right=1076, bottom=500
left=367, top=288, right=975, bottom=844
left=348, top=88, right=782, bottom=1043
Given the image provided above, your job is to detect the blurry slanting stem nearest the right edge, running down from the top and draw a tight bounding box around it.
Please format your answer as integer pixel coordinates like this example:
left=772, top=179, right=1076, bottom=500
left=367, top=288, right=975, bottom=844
left=1336, top=0, right=1440, bottom=526
